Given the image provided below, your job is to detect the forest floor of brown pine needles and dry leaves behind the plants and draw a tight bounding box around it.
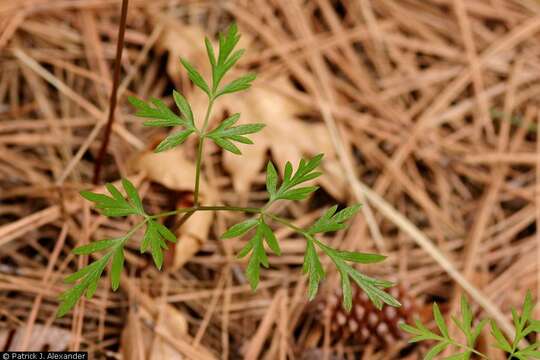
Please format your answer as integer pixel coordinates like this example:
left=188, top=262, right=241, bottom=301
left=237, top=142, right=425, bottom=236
left=0, top=0, right=540, bottom=359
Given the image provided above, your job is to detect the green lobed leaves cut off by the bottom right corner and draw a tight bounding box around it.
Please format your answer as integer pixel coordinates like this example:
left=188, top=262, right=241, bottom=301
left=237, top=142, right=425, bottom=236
left=400, top=292, right=540, bottom=360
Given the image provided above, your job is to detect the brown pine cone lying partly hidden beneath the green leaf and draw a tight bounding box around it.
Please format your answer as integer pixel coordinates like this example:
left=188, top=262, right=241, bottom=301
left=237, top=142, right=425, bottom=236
left=317, top=286, right=417, bottom=344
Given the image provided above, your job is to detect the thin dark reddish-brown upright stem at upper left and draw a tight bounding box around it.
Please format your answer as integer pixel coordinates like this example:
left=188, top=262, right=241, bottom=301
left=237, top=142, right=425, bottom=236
left=93, top=0, right=129, bottom=184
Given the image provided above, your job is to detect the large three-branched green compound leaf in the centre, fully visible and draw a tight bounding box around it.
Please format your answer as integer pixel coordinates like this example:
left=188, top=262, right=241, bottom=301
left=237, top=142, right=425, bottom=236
left=58, top=24, right=400, bottom=316
